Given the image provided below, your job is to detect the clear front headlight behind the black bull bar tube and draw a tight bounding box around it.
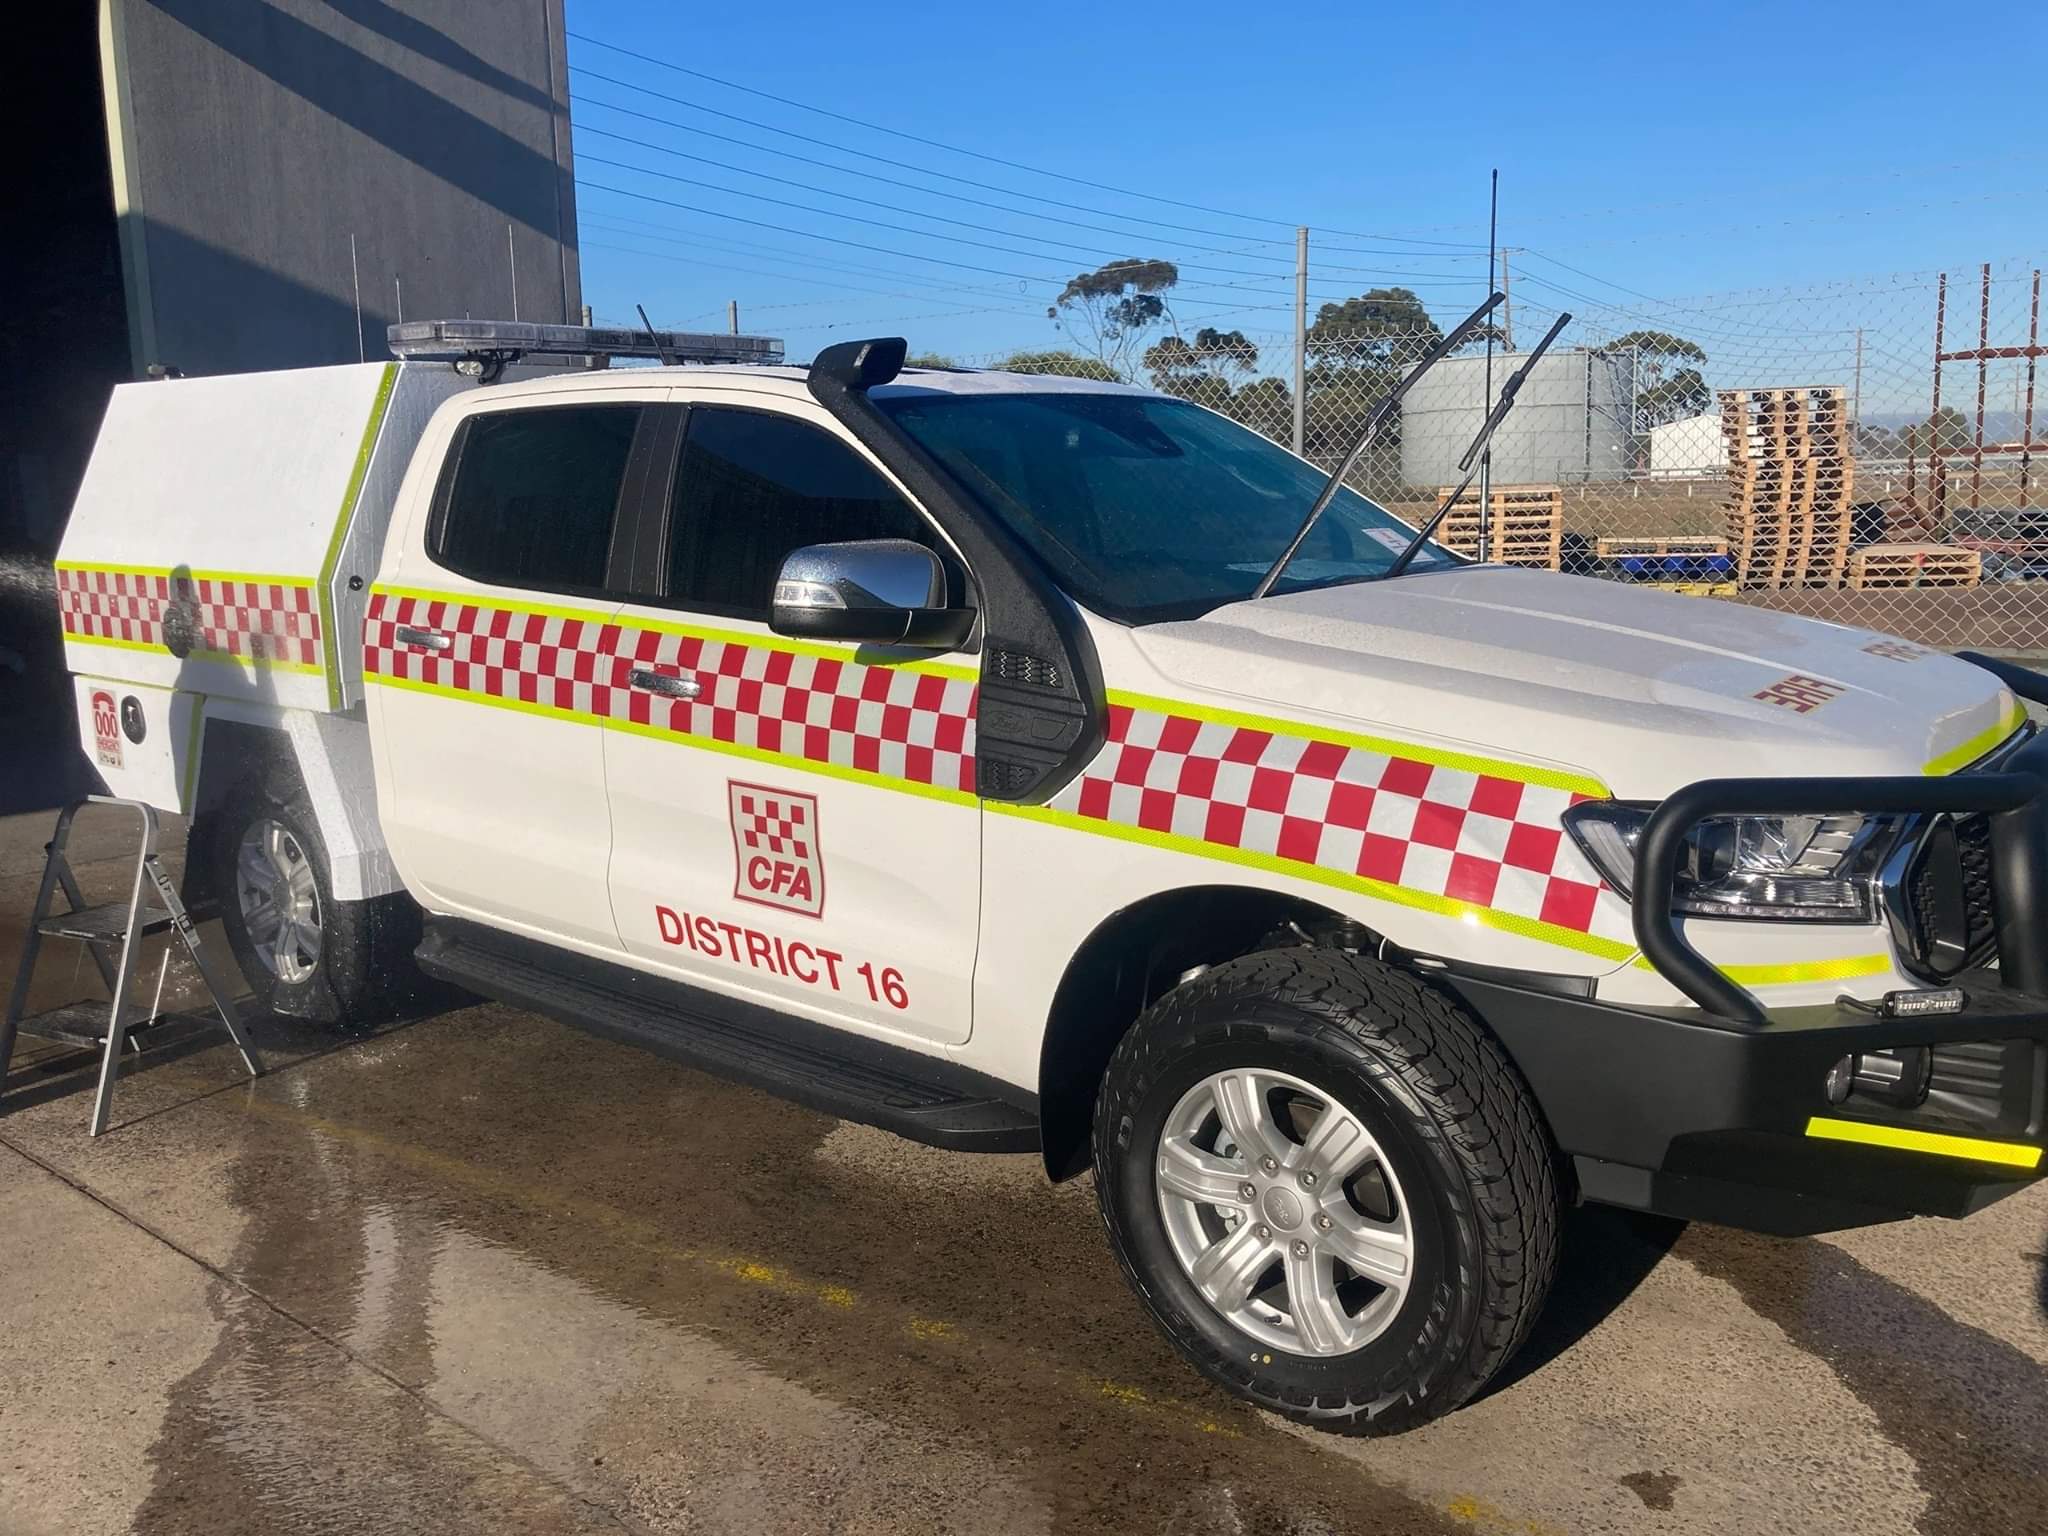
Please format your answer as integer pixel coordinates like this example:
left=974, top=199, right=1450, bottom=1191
left=1565, top=801, right=1896, bottom=924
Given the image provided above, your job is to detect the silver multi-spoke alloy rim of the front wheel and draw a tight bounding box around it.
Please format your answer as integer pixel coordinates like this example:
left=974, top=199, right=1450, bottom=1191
left=1153, top=1067, right=1415, bottom=1356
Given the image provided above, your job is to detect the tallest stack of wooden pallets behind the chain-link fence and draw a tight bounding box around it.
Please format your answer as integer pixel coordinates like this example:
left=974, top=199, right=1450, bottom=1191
left=1720, top=385, right=1855, bottom=588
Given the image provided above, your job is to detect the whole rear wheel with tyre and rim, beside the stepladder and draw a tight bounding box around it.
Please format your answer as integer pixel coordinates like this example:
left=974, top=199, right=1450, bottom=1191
left=209, top=774, right=420, bottom=1030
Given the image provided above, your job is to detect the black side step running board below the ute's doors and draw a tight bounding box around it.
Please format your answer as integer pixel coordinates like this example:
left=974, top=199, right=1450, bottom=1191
left=418, top=918, right=1038, bottom=1151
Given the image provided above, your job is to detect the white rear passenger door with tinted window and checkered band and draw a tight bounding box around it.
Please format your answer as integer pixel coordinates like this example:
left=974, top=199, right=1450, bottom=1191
left=365, top=391, right=666, bottom=952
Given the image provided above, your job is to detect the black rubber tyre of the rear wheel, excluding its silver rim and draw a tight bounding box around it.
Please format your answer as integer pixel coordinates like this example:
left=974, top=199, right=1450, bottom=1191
left=209, top=764, right=428, bottom=1034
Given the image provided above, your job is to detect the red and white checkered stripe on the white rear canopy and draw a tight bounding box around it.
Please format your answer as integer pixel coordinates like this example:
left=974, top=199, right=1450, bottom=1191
left=57, top=565, right=319, bottom=668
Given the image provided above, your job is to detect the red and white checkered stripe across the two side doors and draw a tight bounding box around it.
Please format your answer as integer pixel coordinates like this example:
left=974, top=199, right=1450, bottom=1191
left=362, top=592, right=975, bottom=793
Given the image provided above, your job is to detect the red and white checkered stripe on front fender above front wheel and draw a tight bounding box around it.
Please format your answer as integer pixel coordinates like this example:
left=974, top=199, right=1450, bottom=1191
left=1053, top=705, right=1628, bottom=942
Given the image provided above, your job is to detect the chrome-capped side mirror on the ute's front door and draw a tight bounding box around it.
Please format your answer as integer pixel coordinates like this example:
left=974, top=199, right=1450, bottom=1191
left=768, top=539, right=975, bottom=649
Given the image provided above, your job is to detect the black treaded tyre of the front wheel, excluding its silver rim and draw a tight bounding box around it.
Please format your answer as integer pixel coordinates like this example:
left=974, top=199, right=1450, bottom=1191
left=1094, top=948, right=1561, bottom=1434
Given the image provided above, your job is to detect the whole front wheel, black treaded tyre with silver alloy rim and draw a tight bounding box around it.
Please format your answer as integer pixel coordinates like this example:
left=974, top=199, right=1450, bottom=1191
left=1096, top=948, right=1559, bottom=1432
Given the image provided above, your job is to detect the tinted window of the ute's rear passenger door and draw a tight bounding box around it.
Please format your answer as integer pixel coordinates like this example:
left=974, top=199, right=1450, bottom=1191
left=434, top=406, right=641, bottom=590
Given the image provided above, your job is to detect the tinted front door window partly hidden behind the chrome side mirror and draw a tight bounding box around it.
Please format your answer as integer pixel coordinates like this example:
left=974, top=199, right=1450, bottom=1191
left=668, top=415, right=940, bottom=621
